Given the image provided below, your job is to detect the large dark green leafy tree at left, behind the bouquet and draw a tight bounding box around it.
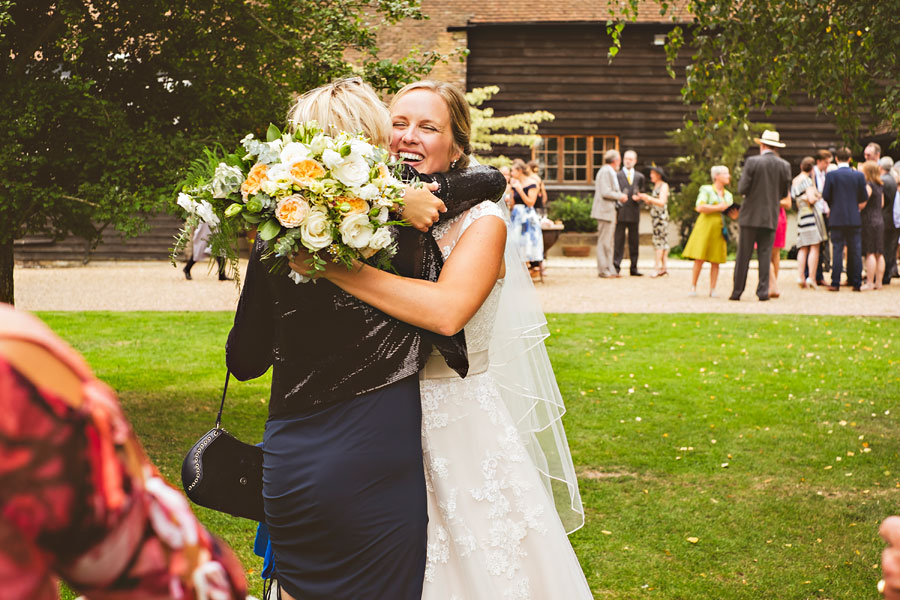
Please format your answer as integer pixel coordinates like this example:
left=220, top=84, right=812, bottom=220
left=0, top=0, right=444, bottom=302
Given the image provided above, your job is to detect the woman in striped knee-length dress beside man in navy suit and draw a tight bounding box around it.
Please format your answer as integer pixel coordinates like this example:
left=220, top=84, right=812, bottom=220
left=791, top=156, right=825, bottom=289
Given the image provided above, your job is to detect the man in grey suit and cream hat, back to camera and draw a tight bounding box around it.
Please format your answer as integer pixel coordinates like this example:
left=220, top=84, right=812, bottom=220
left=730, top=130, right=791, bottom=300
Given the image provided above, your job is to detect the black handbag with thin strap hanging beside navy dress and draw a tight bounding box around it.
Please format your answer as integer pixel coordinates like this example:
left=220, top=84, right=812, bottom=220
left=181, top=371, right=265, bottom=522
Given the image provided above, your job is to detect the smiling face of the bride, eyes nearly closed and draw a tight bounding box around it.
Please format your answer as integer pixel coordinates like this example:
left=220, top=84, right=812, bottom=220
left=391, top=89, right=460, bottom=173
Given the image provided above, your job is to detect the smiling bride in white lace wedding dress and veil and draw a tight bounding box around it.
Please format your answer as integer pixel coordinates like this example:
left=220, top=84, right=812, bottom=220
left=316, top=82, right=592, bottom=600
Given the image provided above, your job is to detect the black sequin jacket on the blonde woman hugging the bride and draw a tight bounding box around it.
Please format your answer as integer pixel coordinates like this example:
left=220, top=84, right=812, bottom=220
left=226, top=166, right=506, bottom=417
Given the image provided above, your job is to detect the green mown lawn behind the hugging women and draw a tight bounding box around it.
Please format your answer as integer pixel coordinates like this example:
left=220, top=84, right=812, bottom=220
left=40, top=313, right=900, bottom=600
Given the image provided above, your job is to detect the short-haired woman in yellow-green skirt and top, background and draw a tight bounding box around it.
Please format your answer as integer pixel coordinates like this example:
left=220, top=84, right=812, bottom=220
left=681, top=165, right=734, bottom=297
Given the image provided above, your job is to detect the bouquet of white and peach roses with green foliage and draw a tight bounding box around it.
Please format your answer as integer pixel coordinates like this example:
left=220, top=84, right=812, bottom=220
left=172, top=121, right=406, bottom=283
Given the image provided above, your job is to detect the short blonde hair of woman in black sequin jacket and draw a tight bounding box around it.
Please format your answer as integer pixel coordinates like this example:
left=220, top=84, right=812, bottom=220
left=288, top=77, right=391, bottom=148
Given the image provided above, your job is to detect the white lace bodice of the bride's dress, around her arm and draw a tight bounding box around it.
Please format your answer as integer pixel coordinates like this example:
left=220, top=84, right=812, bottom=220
left=432, top=202, right=503, bottom=354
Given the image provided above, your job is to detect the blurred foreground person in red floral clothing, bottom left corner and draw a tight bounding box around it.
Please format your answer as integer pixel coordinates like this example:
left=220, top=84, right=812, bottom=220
left=0, top=304, right=247, bottom=600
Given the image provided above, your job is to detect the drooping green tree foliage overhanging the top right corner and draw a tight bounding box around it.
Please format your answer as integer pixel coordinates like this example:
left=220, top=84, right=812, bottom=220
left=607, top=0, right=900, bottom=146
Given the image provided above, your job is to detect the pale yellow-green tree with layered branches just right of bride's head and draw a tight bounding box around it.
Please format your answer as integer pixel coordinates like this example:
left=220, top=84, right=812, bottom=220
left=466, top=85, right=556, bottom=166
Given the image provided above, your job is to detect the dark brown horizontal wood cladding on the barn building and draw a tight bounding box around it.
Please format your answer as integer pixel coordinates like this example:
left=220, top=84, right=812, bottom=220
left=467, top=24, right=864, bottom=182
